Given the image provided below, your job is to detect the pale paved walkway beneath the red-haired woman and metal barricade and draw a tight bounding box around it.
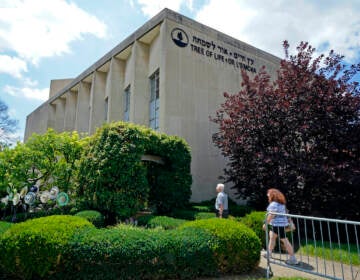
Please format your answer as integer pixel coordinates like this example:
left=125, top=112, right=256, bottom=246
left=202, top=251, right=360, bottom=280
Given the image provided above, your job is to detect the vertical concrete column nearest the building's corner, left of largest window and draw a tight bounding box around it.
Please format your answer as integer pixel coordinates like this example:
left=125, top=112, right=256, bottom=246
left=130, top=41, right=150, bottom=126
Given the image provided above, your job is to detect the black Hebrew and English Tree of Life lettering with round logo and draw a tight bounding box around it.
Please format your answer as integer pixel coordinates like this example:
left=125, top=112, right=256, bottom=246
left=171, top=28, right=257, bottom=73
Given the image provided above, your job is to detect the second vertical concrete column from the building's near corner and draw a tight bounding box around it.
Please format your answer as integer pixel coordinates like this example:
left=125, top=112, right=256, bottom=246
left=105, top=57, right=125, bottom=122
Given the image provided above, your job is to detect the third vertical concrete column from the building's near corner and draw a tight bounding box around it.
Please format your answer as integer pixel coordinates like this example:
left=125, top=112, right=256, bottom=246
left=89, top=71, right=106, bottom=135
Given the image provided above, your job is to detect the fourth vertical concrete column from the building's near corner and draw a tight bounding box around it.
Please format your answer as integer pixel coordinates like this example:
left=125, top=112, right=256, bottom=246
left=75, top=82, right=91, bottom=133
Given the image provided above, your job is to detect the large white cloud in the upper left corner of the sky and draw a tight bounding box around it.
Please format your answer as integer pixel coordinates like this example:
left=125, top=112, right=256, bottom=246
left=0, top=0, right=106, bottom=64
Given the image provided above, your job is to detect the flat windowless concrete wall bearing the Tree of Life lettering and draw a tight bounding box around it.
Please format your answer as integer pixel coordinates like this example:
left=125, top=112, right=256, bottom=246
left=160, top=20, right=278, bottom=201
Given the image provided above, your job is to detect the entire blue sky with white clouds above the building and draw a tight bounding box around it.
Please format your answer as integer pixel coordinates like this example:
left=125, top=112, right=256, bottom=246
left=0, top=0, right=360, bottom=140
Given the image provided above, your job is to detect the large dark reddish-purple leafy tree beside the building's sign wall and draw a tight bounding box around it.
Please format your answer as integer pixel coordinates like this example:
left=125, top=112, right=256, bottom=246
left=211, top=41, right=360, bottom=220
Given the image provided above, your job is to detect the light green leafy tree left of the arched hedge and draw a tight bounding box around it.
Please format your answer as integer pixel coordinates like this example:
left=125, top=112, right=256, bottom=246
left=0, top=129, right=82, bottom=196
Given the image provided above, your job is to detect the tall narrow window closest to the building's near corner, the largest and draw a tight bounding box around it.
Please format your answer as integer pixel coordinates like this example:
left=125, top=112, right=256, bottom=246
left=149, top=70, right=160, bottom=130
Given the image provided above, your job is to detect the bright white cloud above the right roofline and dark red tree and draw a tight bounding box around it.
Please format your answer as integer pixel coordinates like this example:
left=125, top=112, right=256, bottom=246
left=196, top=0, right=360, bottom=61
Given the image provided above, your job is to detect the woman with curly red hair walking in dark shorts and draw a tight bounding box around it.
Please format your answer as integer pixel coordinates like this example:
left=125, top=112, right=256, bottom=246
left=264, top=189, right=299, bottom=265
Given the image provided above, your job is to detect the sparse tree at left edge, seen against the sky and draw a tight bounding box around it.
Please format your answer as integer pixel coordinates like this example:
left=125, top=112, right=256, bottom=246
left=0, top=100, right=18, bottom=151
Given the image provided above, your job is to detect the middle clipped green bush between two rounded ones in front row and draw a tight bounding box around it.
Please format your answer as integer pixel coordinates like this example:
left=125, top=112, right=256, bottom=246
left=57, top=225, right=216, bottom=279
